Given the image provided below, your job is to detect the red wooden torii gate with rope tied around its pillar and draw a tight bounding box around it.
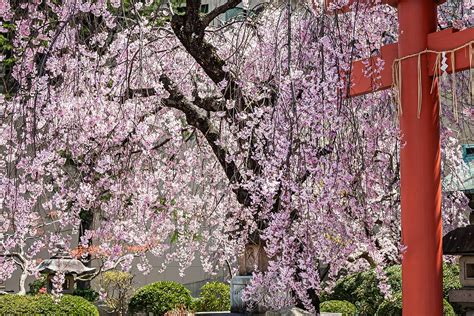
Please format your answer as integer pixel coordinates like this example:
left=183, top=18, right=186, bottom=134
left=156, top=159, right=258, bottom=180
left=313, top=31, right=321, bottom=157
left=325, top=0, right=474, bottom=316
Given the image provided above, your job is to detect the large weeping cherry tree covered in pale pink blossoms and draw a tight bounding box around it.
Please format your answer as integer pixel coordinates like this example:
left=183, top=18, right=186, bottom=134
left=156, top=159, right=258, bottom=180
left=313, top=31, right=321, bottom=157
left=0, top=0, right=473, bottom=309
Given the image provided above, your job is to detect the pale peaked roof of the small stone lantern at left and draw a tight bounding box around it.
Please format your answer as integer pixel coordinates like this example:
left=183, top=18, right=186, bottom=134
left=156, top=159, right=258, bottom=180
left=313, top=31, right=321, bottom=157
left=38, top=245, right=95, bottom=276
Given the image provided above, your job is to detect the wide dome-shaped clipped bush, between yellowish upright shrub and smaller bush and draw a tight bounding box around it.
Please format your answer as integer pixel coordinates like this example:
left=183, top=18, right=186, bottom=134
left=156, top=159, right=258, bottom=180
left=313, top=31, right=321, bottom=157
left=129, top=281, right=192, bottom=316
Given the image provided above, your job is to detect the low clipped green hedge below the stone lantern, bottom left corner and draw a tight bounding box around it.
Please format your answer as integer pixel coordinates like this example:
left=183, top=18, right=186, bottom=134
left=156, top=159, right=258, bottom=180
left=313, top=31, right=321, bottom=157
left=0, top=294, right=99, bottom=316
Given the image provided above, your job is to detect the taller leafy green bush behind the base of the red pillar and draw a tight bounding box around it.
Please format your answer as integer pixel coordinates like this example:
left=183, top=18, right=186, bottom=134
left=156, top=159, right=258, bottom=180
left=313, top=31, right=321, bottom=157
left=321, top=264, right=461, bottom=315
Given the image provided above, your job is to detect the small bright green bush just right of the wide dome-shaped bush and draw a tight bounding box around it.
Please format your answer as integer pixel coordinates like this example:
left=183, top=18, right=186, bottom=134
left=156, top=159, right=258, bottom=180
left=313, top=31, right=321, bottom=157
left=191, top=282, right=230, bottom=312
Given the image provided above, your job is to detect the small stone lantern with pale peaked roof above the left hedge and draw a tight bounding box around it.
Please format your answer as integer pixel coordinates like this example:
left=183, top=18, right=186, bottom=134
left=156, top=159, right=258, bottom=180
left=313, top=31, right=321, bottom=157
left=37, top=245, right=95, bottom=294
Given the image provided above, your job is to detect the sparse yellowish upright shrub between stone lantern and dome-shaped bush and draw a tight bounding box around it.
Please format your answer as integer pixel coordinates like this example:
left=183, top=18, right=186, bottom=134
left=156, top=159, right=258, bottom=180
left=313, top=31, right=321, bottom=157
left=100, top=270, right=133, bottom=315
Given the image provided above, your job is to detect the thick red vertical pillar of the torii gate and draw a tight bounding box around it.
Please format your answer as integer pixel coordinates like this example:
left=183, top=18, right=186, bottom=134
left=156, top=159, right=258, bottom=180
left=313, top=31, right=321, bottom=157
left=398, top=0, right=443, bottom=316
